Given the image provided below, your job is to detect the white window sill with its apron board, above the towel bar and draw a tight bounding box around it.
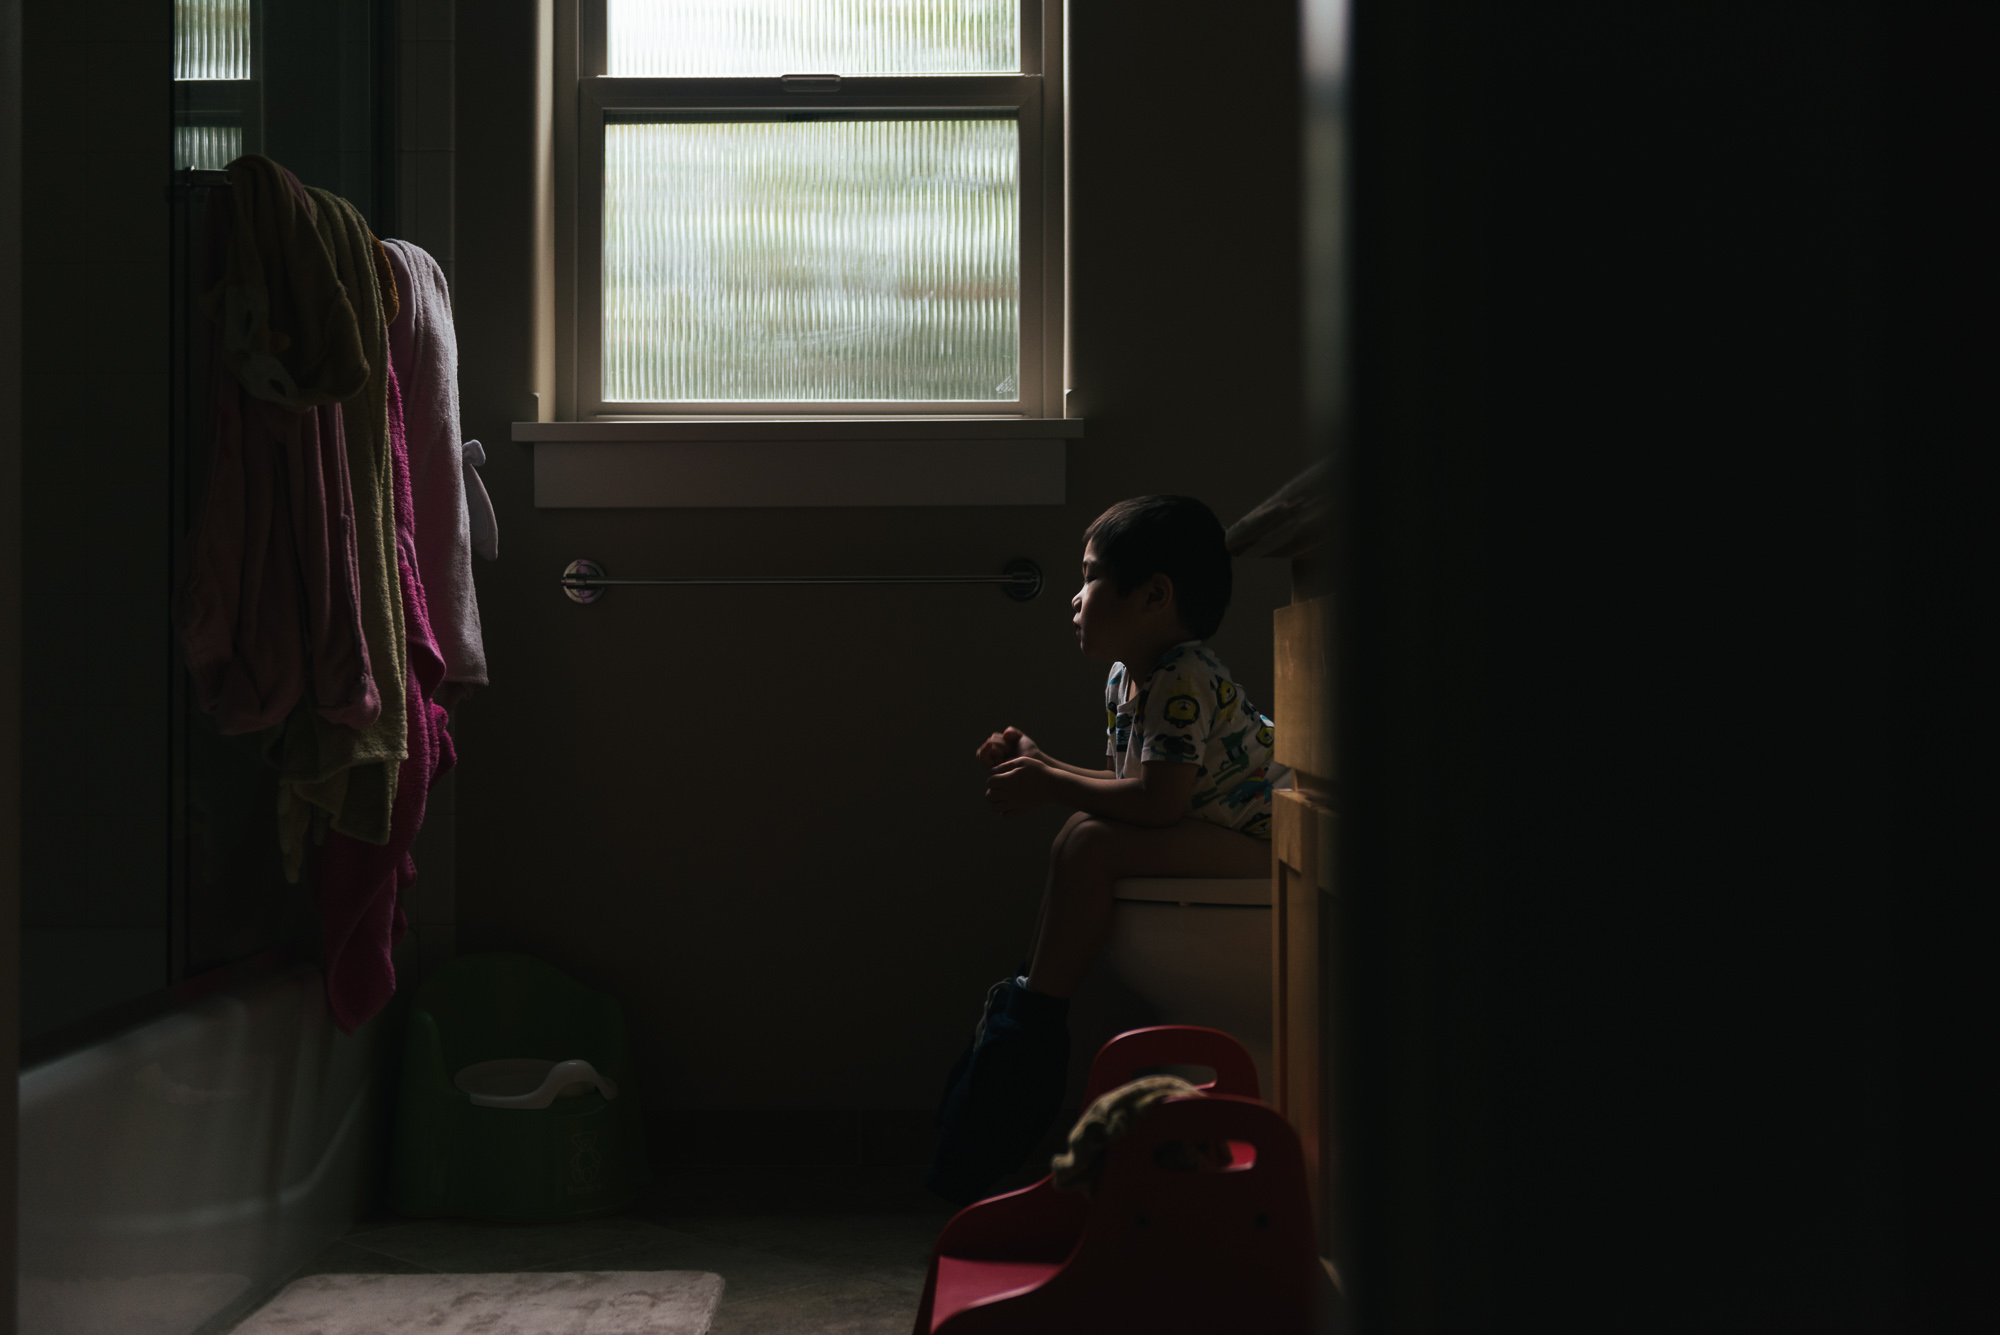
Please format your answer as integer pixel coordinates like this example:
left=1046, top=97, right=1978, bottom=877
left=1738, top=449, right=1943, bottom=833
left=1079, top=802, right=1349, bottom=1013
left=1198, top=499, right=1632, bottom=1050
left=514, top=418, right=1084, bottom=510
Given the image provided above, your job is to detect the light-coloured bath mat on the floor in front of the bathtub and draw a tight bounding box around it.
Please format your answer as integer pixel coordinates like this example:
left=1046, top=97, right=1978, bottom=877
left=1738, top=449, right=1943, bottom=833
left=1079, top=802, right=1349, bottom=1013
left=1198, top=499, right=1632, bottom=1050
left=234, top=1271, right=722, bottom=1335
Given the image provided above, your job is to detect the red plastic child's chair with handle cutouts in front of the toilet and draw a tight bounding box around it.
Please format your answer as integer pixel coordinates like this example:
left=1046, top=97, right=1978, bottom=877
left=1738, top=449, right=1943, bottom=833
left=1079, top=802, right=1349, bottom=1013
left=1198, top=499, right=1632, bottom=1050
left=914, top=1025, right=1320, bottom=1335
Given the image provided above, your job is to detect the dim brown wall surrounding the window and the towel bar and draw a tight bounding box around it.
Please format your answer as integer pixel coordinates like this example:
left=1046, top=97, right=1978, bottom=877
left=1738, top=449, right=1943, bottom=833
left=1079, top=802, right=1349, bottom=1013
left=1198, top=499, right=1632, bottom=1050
left=456, top=0, right=1302, bottom=1109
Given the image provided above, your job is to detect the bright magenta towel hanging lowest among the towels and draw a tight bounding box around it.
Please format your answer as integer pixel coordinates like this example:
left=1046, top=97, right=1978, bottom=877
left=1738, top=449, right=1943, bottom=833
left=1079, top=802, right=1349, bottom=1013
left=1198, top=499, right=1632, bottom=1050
left=318, top=366, right=458, bottom=1033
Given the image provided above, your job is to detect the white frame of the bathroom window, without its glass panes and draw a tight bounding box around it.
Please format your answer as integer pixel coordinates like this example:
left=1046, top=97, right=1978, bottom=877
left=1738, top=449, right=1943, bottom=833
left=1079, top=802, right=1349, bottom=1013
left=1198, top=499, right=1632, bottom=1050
left=554, top=0, right=1068, bottom=422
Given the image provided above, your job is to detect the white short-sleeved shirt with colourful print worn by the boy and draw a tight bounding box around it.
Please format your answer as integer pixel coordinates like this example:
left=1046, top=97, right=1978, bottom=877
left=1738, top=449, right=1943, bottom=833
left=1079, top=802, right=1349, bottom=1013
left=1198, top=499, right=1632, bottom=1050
left=1104, top=640, right=1292, bottom=839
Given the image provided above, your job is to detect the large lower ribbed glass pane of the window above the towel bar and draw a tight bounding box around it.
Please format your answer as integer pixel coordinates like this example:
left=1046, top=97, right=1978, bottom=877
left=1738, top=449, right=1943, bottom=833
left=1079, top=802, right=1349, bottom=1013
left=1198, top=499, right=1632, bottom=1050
left=604, top=120, right=1020, bottom=404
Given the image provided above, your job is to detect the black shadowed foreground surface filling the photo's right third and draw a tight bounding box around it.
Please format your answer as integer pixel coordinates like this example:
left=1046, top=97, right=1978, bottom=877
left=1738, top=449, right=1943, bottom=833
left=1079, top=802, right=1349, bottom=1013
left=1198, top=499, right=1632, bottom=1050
left=1338, top=0, right=1952, bottom=1333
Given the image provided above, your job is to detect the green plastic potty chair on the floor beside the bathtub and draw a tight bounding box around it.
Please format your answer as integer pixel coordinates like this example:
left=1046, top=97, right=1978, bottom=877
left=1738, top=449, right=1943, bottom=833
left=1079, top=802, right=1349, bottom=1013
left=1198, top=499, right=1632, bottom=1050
left=390, top=955, right=646, bottom=1221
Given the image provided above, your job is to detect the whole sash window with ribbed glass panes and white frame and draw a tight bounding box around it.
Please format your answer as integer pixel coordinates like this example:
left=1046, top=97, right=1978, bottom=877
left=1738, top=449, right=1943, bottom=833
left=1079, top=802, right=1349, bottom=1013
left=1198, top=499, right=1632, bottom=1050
left=564, top=0, right=1062, bottom=420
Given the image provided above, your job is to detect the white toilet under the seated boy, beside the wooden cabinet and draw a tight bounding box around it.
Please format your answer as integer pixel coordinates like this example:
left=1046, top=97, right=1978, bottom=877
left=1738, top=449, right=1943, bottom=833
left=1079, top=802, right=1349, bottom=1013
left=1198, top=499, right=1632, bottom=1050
left=1070, top=877, right=1276, bottom=1103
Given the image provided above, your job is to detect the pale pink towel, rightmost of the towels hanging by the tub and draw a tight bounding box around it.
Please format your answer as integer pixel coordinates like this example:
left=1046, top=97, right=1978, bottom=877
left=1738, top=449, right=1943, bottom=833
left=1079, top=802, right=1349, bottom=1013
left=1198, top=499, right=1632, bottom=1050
left=382, top=242, right=490, bottom=687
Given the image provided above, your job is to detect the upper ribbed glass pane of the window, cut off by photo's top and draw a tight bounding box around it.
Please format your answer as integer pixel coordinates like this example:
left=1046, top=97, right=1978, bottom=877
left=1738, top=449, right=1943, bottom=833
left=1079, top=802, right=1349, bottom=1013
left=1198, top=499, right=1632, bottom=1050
left=606, top=0, right=1020, bottom=78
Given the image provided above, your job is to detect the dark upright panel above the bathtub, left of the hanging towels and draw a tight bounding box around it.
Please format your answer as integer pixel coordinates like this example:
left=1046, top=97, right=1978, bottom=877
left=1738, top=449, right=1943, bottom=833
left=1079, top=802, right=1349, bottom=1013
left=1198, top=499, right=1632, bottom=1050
left=20, top=0, right=178, bottom=1035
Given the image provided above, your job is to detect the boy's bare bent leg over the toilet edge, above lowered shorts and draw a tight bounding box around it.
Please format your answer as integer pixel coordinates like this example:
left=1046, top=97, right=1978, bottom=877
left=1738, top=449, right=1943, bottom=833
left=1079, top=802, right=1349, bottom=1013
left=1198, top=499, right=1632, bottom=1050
left=1028, top=813, right=1270, bottom=997
